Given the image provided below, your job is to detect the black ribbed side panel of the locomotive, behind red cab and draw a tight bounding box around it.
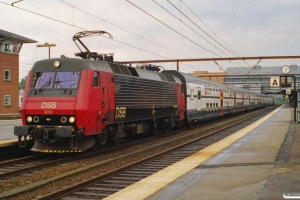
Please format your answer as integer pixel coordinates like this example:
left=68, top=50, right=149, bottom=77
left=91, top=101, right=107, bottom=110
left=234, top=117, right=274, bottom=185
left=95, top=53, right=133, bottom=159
left=114, top=73, right=177, bottom=122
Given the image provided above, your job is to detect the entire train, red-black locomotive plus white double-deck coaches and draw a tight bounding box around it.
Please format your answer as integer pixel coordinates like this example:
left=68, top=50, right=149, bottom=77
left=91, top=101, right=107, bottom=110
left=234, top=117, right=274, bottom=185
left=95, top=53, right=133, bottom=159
left=14, top=31, right=273, bottom=153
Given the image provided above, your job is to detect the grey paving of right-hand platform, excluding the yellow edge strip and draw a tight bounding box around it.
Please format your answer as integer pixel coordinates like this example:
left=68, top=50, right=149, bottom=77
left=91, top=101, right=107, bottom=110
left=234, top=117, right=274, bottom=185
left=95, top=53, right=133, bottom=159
left=147, top=107, right=300, bottom=200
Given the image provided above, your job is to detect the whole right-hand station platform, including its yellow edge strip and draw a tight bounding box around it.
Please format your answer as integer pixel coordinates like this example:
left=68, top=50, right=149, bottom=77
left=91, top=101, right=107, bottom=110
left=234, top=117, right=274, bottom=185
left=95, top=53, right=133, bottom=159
left=106, top=105, right=300, bottom=200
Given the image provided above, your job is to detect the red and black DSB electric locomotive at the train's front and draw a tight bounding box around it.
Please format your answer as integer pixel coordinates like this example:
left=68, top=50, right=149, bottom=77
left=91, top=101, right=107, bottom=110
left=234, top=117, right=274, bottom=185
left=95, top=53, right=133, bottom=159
left=15, top=58, right=185, bottom=152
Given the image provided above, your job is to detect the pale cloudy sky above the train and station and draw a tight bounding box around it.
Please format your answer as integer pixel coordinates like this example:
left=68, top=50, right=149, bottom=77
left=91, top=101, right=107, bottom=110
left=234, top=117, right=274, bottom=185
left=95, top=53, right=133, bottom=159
left=0, top=0, right=300, bottom=79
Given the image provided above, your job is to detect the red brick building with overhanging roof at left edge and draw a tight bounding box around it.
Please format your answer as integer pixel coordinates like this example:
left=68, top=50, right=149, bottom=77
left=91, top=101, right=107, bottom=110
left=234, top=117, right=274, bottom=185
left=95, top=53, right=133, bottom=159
left=0, top=29, right=37, bottom=114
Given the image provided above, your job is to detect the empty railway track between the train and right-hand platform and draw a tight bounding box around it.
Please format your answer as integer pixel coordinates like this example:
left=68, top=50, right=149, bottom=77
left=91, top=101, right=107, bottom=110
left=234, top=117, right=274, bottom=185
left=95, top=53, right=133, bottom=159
left=0, top=109, right=271, bottom=200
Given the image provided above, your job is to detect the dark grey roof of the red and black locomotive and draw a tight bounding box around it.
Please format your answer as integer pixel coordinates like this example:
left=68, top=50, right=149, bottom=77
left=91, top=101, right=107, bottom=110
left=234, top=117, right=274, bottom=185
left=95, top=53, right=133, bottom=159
left=32, top=58, right=181, bottom=83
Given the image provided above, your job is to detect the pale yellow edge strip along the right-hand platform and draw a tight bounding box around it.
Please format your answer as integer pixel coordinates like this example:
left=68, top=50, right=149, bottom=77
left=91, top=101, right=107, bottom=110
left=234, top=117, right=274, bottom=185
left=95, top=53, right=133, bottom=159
left=105, top=106, right=282, bottom=200
